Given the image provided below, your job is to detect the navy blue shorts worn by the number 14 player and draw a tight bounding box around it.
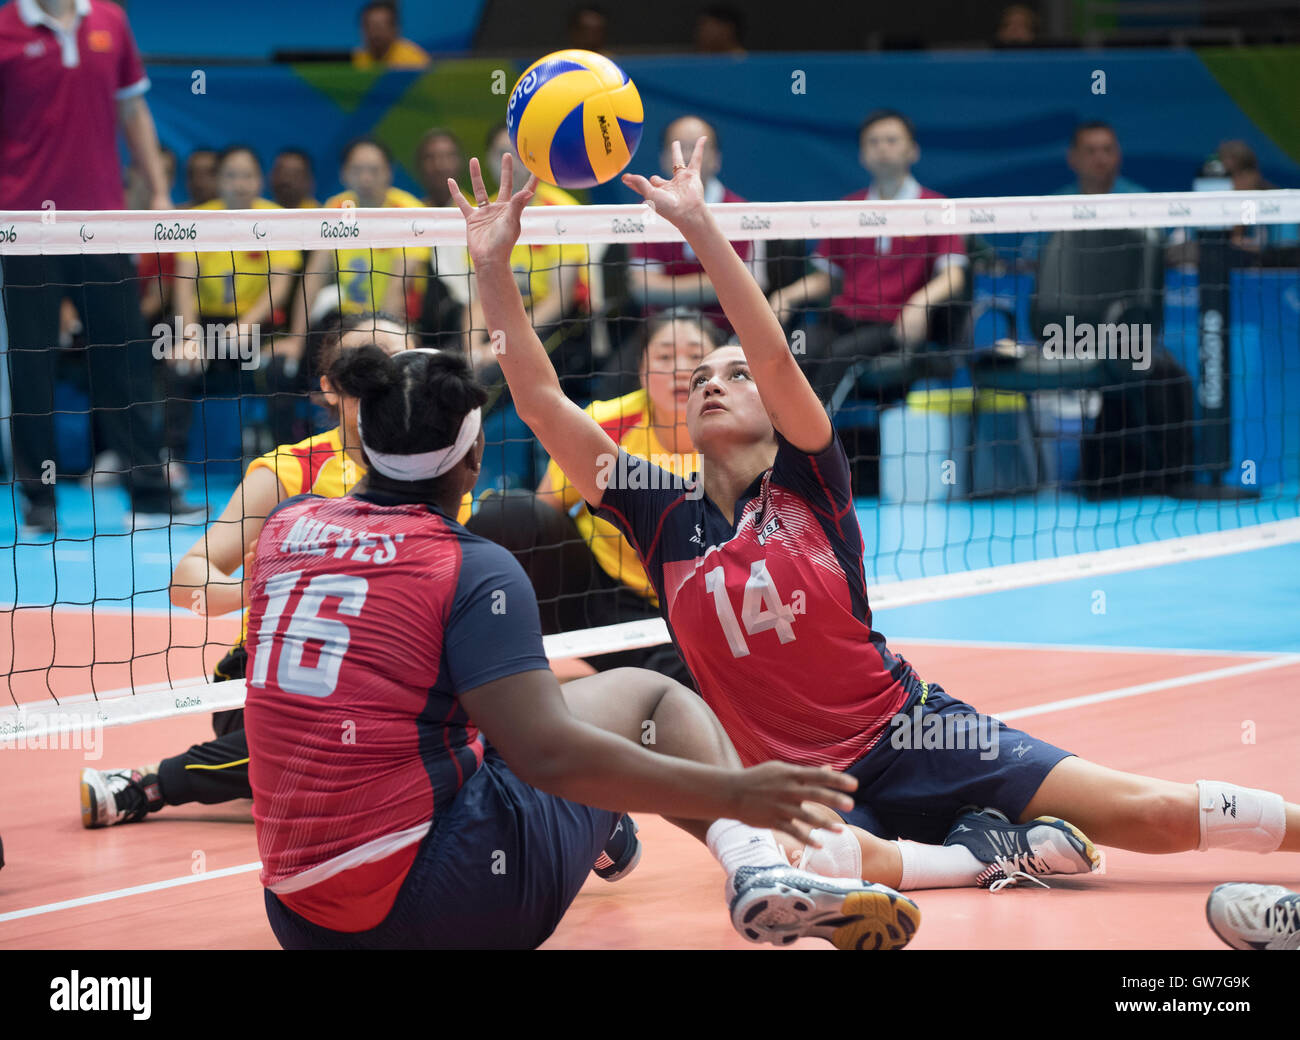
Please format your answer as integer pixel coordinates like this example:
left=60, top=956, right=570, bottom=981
left=840, top=683, right=1073, bottom=845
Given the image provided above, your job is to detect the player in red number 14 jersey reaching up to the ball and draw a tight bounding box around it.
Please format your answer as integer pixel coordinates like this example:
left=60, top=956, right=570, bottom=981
left=454, top=142, right=1300, bottom=889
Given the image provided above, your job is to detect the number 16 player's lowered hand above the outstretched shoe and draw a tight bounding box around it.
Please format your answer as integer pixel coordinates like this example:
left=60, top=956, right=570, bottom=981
left=733, top=762, right=858, bottom=846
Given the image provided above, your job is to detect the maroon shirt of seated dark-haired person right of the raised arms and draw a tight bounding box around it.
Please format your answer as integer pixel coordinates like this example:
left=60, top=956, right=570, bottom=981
left=816, top=179, right=966, bottom=322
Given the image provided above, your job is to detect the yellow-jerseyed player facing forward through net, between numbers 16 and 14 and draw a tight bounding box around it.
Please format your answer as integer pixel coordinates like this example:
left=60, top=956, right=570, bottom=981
left=468, top=308, right=722, bottom=685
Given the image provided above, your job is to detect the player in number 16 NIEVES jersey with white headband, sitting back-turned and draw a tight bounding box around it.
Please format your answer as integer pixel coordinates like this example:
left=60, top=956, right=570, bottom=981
left=244, top=345, right=919, bottom=949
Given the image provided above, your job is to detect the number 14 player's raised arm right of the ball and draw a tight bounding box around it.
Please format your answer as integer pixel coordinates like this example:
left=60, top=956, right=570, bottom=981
left=623, top=138, right=831, bottom=455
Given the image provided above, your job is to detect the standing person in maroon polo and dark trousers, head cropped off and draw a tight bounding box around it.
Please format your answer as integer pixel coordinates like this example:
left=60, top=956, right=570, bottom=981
left=0, top=0, right=194, bottom=534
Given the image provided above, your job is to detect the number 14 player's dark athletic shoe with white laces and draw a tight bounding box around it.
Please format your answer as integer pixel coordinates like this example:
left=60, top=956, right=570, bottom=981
left=944, top=809, right=1101, bottom=892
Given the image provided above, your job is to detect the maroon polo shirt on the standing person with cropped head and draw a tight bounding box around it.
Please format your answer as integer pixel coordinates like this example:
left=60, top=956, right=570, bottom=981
left=0, top=0, right=150, bottom=209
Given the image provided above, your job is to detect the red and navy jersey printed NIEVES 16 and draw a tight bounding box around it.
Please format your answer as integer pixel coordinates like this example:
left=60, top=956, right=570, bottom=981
left=244, top=494, right=550, bottom=932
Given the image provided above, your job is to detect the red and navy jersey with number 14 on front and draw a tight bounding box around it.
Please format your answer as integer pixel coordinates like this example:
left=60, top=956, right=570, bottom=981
left=598, top=436, right=920, bottom=770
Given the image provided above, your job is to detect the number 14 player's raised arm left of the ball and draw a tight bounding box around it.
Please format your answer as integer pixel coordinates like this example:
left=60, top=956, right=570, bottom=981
left=447, top=155, right=619, bottom=506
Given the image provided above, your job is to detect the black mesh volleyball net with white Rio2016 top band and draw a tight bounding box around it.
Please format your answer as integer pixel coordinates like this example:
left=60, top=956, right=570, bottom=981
left=0, top=191, right=1300, bottom=742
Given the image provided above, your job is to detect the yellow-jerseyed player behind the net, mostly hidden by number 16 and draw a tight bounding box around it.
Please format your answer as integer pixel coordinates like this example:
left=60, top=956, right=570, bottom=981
left=81, top=315, right=452, bottom=827
